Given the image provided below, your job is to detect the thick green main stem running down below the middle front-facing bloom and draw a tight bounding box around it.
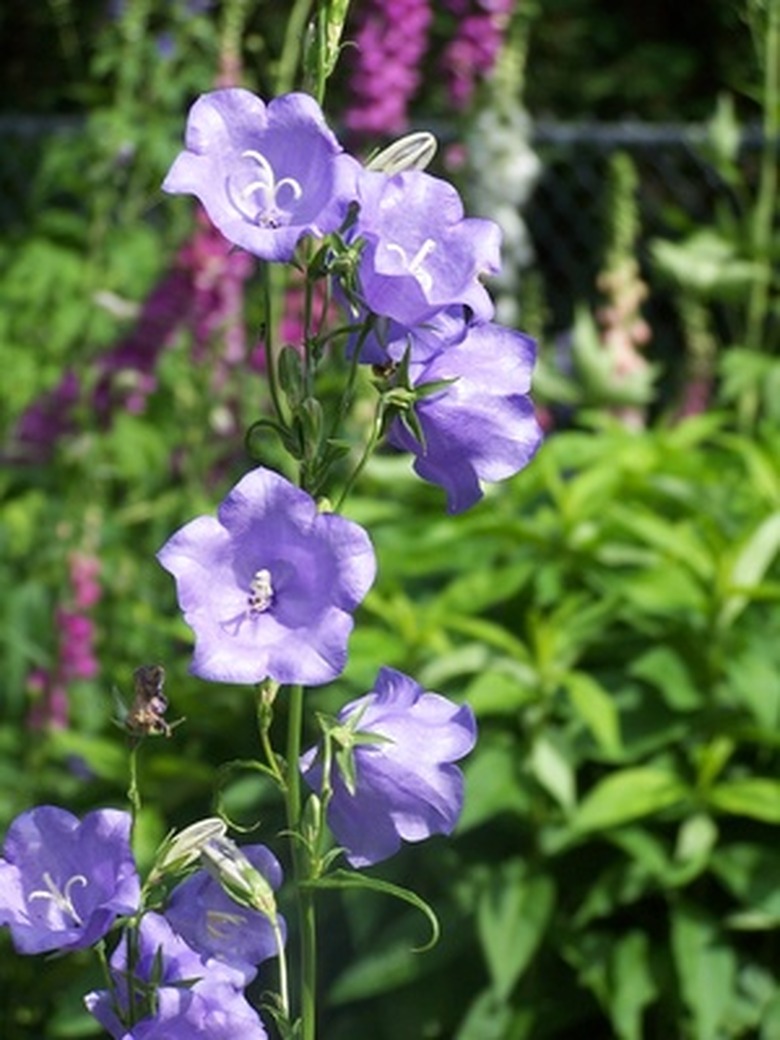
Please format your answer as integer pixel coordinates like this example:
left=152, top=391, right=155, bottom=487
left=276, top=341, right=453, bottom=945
left=286, top=685, right=317, bottom=1040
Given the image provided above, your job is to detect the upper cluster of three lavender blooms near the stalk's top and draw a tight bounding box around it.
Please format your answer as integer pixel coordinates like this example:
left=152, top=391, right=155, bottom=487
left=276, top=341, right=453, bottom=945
left=163, top=89, right=541, bottom=511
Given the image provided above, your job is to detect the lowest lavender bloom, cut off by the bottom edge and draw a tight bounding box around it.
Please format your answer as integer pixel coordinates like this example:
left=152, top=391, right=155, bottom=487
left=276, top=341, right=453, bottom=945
left=84, top=913, right=266, bottom=1040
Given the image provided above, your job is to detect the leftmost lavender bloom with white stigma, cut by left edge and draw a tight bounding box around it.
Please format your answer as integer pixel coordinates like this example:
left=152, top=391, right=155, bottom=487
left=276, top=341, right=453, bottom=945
left=0, top=805, right=140, bottom=954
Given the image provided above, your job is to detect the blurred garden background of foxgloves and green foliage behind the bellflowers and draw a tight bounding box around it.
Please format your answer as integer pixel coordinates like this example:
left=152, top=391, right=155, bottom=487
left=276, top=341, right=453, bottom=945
left=0, top=0, right=780, bottom=1040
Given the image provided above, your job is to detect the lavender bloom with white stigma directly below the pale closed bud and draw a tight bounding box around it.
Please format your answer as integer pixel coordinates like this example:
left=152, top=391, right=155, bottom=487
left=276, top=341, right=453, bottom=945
left=353, top=170, right=501, bottom=327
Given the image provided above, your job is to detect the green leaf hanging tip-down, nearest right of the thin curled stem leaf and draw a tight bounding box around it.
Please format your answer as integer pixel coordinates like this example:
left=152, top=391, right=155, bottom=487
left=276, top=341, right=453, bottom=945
left=476, top=859, right=555, bottom=1000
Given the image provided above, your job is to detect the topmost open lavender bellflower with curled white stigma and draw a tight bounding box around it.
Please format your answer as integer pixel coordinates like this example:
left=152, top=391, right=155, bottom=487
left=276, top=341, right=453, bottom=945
left=162, top=87, right=360, bottom=261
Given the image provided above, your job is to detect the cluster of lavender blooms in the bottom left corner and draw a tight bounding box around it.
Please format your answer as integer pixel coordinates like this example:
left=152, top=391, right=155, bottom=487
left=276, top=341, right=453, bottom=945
left=0, top=805, right=285, bottom=1040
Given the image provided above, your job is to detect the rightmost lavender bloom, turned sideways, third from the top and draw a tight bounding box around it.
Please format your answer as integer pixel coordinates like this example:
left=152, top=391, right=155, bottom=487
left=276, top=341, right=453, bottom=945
left=388, top=323, right=542, bottom=513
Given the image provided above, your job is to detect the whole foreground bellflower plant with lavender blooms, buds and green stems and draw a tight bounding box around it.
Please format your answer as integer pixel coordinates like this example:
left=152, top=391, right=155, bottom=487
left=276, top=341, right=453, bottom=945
left=0, top=0, right=540, bottom=1040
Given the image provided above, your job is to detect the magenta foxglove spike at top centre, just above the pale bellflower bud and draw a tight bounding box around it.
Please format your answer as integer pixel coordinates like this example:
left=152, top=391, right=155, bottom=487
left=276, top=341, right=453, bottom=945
left=344, top=0, right=433, bottom=136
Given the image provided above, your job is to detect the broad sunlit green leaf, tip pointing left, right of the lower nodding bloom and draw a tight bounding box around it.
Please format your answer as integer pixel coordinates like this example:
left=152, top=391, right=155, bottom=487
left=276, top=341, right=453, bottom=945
left=572, top=765, right=687, bottom=831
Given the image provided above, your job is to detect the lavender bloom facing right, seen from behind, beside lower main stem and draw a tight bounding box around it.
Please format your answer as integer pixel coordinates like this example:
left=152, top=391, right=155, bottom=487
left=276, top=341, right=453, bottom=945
left=301, top=668, right=476, bottom=866
